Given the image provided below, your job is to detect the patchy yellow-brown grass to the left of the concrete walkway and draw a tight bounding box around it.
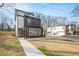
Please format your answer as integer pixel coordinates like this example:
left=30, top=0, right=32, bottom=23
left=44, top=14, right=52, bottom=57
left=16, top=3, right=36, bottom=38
left=0, top=31, right=25, bottom=56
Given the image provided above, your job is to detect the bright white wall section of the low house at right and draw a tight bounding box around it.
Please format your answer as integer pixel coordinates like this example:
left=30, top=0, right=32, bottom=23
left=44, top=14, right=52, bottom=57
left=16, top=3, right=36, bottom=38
left=47, top=26, right=65, bottom=36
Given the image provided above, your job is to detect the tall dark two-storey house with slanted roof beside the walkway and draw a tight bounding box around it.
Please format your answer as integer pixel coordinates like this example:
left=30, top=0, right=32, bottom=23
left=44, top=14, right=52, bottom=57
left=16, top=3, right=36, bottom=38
left=15, top=9, right=43, bottom=38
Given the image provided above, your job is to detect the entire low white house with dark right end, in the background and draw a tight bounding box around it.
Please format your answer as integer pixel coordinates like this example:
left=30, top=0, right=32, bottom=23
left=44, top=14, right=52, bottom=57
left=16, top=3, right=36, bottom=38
left=47, top=24, right=76, bottom=36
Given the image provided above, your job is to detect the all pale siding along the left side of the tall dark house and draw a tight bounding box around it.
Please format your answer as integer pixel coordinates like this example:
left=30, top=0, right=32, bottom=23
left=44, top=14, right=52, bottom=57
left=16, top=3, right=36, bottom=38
left=15, top=11, right=24, bottom=37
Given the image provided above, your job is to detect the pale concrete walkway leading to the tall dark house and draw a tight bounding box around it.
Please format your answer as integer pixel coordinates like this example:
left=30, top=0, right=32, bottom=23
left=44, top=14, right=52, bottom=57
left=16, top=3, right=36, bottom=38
left=19, top=38, right=45, bottom=56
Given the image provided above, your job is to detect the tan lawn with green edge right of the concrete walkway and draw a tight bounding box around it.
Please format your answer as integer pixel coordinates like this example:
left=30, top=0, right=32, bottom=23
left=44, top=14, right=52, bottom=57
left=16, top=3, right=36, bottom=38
left=29, top=38, right=79, bottom=56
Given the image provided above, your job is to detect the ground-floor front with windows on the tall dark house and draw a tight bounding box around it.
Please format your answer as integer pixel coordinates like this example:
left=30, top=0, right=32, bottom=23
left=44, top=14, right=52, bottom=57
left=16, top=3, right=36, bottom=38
left=18, top=28, right=42, bottom=37
